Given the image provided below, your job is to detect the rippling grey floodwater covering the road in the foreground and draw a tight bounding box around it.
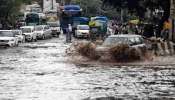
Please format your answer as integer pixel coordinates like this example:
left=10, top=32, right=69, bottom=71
left=0, top=37, right=175, bottom=100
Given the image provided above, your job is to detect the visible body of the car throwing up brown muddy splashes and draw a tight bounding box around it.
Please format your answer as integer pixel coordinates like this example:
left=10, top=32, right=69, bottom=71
left=96, top=34, right=146, bottom=53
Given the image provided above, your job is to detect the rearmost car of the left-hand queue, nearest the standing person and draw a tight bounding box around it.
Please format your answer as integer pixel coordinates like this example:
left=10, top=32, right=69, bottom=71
left=47, top=21, right=61, bottom=37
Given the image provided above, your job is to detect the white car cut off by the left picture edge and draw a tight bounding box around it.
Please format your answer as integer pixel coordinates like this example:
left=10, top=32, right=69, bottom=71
left=0, top=30, right=19, bottom=47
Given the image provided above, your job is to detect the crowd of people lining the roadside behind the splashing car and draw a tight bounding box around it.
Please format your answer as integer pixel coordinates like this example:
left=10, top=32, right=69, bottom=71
left=109, top=21, right=171, bottom=40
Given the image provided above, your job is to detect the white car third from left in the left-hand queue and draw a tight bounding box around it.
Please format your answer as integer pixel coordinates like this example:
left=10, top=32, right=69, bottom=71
left=21, top=26, right=37, bottom=42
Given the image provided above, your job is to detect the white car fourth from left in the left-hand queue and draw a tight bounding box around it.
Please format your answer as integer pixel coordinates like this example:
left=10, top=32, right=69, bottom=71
left=35, top=25, right=52, bottom=39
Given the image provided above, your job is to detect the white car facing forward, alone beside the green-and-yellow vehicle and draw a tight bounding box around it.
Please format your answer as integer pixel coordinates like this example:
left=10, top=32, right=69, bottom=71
left=75, top=25, right=90, bottom=37
